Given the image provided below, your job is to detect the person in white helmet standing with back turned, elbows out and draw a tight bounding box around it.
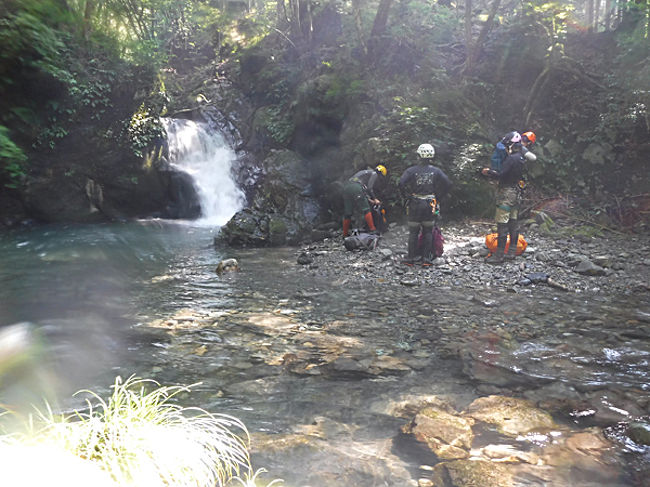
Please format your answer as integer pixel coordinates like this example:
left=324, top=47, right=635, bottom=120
left=399, top=144, right=451, bottom=266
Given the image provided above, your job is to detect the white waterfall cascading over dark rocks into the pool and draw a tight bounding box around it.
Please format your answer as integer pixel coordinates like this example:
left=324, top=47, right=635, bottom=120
left=163, top=118, right=245, bottom=226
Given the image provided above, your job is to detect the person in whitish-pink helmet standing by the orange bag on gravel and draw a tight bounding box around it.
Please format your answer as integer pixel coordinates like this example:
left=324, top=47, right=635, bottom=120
left=481, top=139, right=532, bottom=264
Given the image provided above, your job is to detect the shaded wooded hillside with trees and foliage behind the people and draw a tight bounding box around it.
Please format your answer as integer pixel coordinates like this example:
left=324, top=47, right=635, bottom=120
left=0, top=0, right=650, bottom=229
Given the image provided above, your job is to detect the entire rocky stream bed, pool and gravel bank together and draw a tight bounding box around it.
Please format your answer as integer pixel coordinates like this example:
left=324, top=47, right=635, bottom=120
left=0, top=218, right=650, bottom=487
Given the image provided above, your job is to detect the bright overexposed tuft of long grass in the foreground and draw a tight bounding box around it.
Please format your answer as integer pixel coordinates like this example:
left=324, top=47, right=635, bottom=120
left=0, top=376, right=279, bottom=487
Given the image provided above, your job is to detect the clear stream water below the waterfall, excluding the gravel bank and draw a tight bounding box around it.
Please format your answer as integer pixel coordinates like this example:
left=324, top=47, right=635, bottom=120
left=0, top=222, right=650, bottom=486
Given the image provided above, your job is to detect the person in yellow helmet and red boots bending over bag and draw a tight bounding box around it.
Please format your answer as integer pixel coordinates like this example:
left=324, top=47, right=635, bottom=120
left=343, top=164, right=388, bottom=237
